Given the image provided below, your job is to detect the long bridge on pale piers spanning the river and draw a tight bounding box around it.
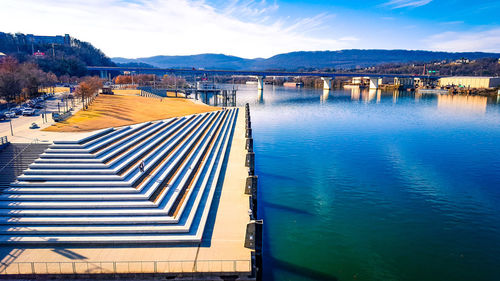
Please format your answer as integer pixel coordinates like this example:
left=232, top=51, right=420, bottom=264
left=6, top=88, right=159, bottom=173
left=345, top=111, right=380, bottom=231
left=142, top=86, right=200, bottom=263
left=87, top=66, right=441, bottom=90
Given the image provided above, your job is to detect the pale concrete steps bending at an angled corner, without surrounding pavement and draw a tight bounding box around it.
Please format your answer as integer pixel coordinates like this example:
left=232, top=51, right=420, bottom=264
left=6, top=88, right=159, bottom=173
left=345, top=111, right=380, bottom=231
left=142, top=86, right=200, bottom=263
left=0, top=109, right=238, bottom=244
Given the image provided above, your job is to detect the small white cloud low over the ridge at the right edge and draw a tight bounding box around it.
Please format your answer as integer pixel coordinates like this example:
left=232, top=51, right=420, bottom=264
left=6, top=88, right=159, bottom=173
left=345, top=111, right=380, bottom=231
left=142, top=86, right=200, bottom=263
left=424, top=28, right=500, bottom=52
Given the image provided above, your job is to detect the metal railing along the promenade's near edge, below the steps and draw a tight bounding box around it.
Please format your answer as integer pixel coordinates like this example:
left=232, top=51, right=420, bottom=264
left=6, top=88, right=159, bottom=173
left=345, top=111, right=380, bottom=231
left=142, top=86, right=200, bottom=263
left=0, top=260, right=252, bottom=275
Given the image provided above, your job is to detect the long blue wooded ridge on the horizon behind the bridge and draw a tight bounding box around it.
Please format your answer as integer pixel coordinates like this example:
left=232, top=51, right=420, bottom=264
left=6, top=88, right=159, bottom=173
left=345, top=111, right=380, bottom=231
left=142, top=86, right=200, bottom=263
left=112, top=50, right=500, bottom=70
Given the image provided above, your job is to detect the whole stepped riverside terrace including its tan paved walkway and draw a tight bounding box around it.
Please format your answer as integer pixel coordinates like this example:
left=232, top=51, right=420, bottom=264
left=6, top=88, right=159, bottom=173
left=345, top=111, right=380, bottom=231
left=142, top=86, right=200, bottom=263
left=0, top=108, right=252, bottom=276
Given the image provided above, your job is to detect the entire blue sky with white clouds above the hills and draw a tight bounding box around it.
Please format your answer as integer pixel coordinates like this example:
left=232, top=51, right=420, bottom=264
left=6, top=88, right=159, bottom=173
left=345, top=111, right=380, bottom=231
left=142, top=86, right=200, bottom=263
left=0, top=0, right=500, bottom=58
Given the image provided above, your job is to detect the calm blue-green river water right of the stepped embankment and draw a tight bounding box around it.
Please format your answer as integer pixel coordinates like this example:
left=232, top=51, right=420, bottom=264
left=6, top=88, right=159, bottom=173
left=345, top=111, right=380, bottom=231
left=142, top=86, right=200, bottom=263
left=233, top=86, right=500, bottom=281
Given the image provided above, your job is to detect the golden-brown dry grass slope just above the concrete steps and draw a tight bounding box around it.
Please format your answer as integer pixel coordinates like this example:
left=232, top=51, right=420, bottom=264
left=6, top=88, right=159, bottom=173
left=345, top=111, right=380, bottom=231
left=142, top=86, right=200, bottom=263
left=44, top=93, right=220, bottom=132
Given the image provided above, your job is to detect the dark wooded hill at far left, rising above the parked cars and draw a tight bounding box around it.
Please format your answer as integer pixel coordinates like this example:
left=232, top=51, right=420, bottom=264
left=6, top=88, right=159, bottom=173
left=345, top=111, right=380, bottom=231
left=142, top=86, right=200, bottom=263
left=0, top=32, right=115, bottom=76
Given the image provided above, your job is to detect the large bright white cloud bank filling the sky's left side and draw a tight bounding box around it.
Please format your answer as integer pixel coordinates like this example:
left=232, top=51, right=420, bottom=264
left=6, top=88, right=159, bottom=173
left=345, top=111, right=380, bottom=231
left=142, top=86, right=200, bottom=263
left=0, top=0, right=351, bottom=58
